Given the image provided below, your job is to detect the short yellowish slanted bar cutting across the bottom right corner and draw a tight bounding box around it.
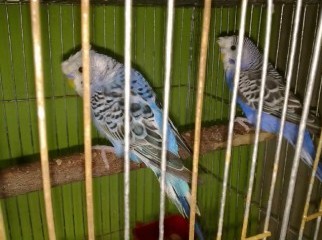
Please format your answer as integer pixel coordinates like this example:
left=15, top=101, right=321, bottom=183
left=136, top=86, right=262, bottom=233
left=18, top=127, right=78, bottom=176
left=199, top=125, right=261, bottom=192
left=299, top=135, right=322, bottom=239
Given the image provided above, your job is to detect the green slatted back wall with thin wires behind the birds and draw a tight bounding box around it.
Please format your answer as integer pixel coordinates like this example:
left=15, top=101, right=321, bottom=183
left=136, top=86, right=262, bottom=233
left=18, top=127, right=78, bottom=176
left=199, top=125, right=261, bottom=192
left=0, top=1, right=322, bottom=239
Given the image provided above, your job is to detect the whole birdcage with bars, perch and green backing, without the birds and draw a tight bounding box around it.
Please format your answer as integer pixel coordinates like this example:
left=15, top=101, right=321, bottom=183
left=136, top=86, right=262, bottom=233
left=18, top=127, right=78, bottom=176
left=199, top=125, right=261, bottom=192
left=0, top=0, right=322, bottom=240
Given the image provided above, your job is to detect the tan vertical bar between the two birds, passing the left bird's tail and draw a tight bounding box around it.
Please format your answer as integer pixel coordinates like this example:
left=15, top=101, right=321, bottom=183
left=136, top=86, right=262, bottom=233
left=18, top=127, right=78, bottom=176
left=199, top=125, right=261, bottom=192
left=189, top=0, right=211, bottom=240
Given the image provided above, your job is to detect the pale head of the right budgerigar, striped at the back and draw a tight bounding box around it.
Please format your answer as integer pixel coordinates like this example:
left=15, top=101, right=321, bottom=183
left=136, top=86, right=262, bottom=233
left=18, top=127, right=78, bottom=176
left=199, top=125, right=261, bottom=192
left=217, top=35, right=262, bottom=70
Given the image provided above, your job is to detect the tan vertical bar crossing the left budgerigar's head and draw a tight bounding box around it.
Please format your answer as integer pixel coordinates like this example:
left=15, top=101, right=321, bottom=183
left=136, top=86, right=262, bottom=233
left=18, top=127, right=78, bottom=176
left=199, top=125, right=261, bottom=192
left=81, top=0, right=95, bottom=239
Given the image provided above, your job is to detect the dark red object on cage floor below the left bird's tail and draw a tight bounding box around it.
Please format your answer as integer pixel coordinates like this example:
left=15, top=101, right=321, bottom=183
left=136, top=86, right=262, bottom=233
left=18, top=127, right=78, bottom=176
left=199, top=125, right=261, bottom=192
left=133, top=215, right=189, bottom=240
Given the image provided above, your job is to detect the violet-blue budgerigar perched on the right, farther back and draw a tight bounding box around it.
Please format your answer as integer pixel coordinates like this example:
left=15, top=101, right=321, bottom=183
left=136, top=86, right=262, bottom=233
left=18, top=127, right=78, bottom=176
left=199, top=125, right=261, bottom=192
left=217, top=36, right=322, bottom=181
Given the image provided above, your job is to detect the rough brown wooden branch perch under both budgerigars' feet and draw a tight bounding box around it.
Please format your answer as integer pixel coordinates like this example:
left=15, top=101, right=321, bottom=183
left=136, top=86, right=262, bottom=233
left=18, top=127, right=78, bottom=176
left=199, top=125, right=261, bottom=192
left=0, top=123, right=274, bottom=198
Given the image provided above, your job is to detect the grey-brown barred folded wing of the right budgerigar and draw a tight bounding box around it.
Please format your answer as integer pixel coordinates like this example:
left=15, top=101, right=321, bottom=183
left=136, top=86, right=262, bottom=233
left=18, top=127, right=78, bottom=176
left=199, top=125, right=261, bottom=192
left=239, top=64, right=320, bottom=133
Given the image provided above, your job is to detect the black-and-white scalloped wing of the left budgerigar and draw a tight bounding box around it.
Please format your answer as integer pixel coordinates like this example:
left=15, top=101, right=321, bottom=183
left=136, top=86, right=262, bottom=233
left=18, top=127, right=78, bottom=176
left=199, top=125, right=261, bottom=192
left=91, top=71, right=191, bottom=181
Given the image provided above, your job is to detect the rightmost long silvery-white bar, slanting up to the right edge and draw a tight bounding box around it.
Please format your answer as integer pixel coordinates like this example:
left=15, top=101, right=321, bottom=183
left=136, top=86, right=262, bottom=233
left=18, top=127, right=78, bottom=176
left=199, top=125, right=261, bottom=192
left=280, top=10, right=322, bottom=240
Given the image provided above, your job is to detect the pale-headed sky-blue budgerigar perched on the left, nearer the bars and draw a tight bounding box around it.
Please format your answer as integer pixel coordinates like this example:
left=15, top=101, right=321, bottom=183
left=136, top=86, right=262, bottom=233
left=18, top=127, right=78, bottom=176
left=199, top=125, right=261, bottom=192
left=62, top=50, right=203, bottom=239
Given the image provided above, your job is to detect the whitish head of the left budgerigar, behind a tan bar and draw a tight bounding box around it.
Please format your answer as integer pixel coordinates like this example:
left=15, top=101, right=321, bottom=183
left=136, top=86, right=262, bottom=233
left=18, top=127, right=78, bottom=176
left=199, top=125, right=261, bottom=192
left=61, top=50, right=115, bottom=96
